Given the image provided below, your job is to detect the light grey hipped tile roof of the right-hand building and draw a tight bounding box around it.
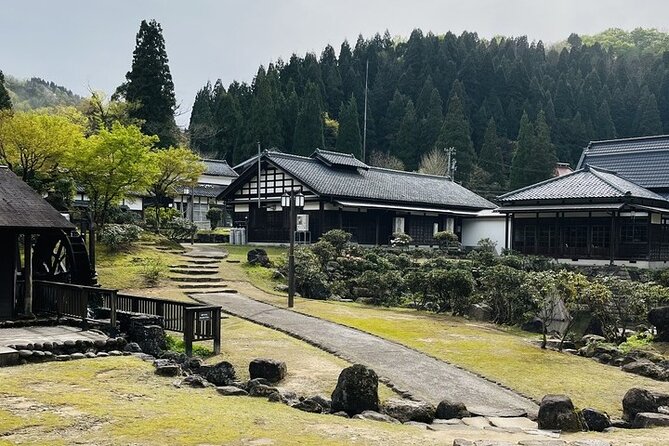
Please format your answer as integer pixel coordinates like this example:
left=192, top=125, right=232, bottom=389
left=499, top=165, right=664, bottom=203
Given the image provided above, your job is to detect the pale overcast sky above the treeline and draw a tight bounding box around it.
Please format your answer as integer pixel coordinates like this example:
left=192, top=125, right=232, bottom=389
left=0, top=0, right=669, bottom=125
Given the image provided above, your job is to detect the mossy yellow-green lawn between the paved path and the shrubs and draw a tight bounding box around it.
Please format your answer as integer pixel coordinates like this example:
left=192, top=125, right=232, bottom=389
left=222, top=247, right=669, bottom=415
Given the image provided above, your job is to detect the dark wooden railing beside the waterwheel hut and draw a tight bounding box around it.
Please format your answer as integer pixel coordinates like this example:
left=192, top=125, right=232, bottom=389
left=33, top=280, right=221, bottom=356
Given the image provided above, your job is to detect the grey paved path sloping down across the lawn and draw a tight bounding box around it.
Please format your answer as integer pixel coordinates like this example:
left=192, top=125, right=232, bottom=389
left=193, top=293, right=539, bottom=417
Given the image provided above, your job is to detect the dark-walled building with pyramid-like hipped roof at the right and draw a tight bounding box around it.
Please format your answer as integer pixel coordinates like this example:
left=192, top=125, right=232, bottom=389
left=497, top=165, right=669, bottom=267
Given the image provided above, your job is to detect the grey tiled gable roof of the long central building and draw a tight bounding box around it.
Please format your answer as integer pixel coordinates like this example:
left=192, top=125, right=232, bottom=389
left=256, top=152, right=496, bottom=210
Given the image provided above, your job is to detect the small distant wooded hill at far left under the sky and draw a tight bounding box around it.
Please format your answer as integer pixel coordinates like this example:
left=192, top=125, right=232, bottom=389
left=5, top=75, right=82, bottom=110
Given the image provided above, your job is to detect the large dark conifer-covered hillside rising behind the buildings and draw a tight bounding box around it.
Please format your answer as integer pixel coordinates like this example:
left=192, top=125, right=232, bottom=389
left=189, top=30, right=669, bottom=193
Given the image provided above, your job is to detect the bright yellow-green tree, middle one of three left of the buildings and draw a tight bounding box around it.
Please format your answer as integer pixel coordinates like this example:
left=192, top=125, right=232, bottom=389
left=66, top=123, right=158, bottom=226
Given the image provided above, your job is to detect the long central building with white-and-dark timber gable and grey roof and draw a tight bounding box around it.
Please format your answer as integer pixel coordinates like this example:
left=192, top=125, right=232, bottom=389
left=218, top=150, right=496, bottom=245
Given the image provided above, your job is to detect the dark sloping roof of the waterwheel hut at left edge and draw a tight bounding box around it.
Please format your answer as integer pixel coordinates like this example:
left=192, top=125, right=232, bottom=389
left=0, top=166, right=74, bottom=230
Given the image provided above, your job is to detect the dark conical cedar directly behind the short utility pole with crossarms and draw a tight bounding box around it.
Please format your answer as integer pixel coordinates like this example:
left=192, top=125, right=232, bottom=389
left=435, top=93, right=476, bottom=185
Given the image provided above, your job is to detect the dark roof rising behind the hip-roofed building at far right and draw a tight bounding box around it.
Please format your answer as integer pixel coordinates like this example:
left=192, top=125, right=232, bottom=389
left=578, top=135, right=669, bottom=189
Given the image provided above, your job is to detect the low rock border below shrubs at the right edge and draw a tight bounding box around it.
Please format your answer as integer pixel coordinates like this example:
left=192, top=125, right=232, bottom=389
left=570, top=336, right=669, bottom=381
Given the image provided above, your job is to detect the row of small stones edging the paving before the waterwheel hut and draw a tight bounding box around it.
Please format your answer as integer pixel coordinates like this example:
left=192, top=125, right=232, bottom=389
left=9, top=337, right=136, bottom=364
